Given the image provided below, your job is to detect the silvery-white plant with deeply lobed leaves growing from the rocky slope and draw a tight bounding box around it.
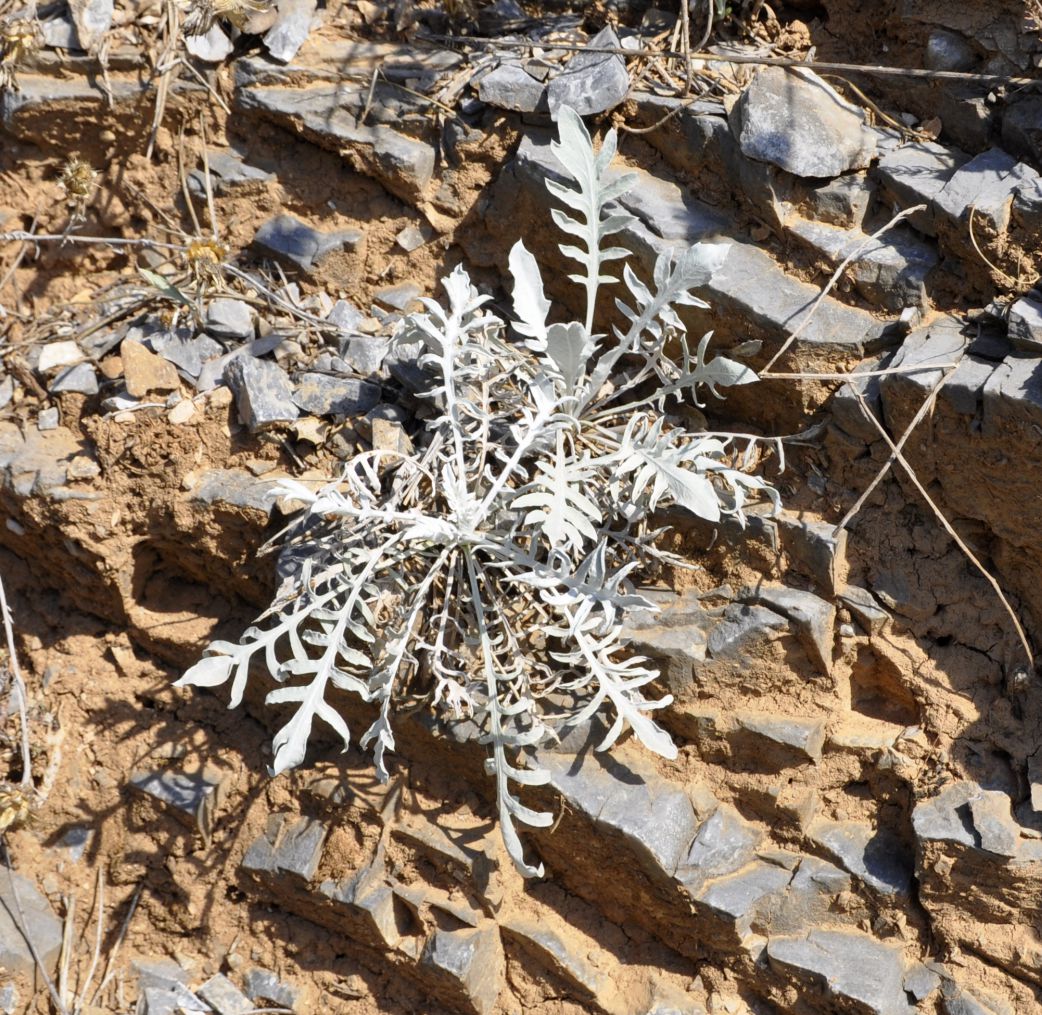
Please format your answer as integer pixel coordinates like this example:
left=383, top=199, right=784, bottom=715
left=178, top=108, right=775, bottom=875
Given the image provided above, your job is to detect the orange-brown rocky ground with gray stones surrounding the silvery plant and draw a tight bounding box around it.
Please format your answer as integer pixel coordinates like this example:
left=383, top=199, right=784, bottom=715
left=0, top=0, right=1042, bottom=1015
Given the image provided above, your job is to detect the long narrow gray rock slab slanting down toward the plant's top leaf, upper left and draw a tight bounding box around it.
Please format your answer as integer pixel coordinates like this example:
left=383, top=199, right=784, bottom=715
left=235, top=84, right=435, bottom=204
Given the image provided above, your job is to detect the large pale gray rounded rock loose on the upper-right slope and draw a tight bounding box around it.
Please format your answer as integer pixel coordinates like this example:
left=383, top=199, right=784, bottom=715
left=731, top=67, right=875, bottom=177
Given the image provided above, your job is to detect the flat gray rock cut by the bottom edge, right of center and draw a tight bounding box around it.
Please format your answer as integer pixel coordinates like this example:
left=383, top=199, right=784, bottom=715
left=767, top=930, right=915, bottom=1015
